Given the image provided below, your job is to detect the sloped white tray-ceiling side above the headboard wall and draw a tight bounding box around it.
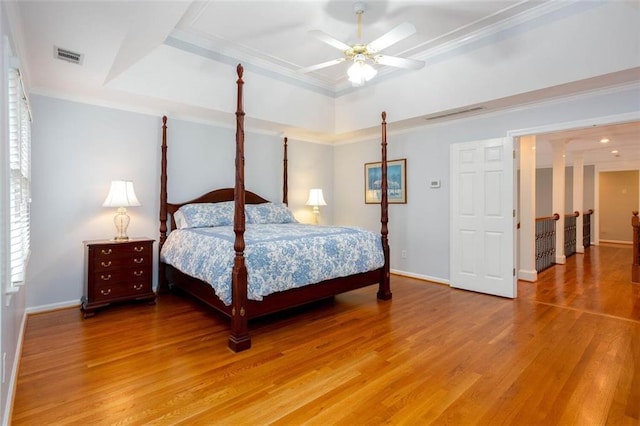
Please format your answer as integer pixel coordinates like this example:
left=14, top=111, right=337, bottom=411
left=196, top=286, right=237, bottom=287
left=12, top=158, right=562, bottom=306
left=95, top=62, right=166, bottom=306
left=108, top=45, right=334, bottom=133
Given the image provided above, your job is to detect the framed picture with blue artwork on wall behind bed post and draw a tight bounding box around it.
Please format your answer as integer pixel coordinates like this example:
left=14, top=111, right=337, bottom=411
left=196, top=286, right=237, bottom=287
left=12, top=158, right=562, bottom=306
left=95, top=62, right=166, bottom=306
left=364, top=158, right=407, bottom=204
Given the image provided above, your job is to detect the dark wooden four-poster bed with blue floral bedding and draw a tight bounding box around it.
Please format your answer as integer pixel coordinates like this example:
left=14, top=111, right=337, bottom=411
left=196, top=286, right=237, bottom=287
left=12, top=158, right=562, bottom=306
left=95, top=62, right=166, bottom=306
left=158, top=65, right=391, bottom=352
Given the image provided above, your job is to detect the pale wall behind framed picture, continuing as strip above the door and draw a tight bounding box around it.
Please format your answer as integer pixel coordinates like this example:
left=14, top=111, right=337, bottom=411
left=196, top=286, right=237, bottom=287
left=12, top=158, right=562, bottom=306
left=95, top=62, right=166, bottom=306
left=334, top=87, right=640, bottom=282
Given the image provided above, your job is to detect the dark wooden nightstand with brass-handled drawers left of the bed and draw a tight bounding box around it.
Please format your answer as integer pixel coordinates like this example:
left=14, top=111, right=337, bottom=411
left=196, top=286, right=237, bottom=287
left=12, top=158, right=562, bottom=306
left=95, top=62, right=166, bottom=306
left=81, top=238, right=156, bottom=318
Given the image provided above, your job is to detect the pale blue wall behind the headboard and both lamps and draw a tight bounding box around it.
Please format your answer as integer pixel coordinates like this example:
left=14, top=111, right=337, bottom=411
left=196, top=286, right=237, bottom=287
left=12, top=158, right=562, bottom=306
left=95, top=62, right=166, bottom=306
left=27, top=96, right=333, bottom=309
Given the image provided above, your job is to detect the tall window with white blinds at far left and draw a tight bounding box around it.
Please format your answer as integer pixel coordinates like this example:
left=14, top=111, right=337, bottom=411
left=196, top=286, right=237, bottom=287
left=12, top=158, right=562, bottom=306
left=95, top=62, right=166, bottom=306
left=7, top=64, right=31, bottom=288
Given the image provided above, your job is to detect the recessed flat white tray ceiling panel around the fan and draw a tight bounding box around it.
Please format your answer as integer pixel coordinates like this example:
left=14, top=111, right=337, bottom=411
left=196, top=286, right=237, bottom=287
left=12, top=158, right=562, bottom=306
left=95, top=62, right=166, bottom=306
left=170, top=0, right=545, bottom=89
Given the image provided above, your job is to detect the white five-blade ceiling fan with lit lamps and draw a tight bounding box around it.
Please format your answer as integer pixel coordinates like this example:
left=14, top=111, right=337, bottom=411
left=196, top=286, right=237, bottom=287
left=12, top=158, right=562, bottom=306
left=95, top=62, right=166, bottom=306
left=298, top=2, right=424, bottom=86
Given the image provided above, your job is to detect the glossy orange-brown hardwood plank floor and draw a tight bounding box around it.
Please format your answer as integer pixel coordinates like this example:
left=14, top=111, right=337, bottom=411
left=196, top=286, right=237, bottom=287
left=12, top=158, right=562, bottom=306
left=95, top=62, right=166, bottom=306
left=12, top=246, right=640, bottom=425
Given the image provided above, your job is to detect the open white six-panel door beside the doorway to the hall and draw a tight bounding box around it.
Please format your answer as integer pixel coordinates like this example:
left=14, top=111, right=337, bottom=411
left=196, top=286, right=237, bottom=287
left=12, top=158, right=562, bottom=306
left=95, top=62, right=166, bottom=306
left=450, top=138, right=517, bottom=298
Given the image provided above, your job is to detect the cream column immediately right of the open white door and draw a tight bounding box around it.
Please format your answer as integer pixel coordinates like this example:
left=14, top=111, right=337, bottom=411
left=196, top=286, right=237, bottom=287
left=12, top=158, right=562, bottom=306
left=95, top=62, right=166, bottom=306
left=518, top=135, right=538, bottom=281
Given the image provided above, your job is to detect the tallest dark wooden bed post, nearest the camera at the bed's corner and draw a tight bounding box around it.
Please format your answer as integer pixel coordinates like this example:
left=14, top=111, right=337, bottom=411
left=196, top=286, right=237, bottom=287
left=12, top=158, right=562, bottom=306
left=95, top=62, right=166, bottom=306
left=229, top=64, right=251, bottom=352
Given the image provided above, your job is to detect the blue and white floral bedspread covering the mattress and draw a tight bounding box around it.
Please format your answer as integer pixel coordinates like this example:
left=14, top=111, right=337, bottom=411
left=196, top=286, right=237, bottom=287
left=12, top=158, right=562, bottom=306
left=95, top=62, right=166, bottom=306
left=160, top=223, right=384, bottom=305
